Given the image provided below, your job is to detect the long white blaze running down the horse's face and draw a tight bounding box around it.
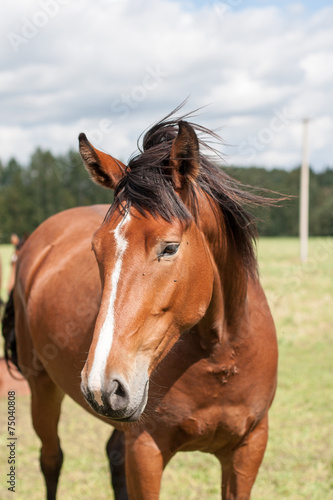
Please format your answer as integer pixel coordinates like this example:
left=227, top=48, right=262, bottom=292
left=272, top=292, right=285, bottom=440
left=88, top=212, right=130, bottom=404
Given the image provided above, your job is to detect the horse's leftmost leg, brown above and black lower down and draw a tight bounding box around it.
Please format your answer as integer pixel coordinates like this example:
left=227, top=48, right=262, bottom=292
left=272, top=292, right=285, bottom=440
left=29, top=371, right=64, bottom=500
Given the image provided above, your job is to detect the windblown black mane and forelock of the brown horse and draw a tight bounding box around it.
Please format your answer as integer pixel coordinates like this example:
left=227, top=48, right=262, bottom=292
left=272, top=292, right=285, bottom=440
left=107, top=108, right=276, bottom=273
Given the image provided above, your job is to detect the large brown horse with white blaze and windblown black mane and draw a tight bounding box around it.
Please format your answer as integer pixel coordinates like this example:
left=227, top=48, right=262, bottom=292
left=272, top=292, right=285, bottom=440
left=7, top=115, right=277, bottom=500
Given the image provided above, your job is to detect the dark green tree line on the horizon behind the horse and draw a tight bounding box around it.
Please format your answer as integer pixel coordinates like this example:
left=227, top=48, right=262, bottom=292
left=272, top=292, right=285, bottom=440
left=0, top=148, right=333, bottom=243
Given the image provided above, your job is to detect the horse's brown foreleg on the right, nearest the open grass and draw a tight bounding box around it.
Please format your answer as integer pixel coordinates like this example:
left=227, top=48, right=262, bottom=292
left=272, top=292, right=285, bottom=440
left=216, top=415, right=268, bottom=500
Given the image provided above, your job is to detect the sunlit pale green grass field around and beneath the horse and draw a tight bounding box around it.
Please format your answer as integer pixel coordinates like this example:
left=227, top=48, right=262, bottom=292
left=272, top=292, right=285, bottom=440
left=0, top=238, right=333, bottom=500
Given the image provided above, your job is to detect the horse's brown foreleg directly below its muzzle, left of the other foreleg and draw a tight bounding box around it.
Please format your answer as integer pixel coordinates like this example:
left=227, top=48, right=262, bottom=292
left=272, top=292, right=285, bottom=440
left=125, top=432, right=170, bottom=500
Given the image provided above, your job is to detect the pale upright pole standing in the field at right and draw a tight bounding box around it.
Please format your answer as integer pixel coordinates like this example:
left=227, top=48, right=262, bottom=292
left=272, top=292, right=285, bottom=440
left=299, top=118, right=309, bottom=262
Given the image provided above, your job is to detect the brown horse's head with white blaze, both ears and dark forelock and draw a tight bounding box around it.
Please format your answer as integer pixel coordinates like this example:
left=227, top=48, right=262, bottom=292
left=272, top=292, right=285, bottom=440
left=80, top=121, right=214, bottom=422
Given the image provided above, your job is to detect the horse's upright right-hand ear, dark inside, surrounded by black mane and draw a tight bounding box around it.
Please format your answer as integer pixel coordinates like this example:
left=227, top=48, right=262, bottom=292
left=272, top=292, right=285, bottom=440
left=170, top=121, right=200, bottom=191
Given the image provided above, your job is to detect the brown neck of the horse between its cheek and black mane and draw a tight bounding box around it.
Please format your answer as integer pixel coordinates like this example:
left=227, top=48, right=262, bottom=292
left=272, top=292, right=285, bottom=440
left=198, top=190, right=248, bottom=338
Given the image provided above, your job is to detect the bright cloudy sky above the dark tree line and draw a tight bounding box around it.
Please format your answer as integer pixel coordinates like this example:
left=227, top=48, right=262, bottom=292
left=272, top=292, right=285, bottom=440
left=0, top=0, right=333, bottom=171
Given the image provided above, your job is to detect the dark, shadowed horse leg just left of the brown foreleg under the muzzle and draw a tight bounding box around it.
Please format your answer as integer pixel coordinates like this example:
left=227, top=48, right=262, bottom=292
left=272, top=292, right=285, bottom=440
left=106, top=429, right=128, bottom=500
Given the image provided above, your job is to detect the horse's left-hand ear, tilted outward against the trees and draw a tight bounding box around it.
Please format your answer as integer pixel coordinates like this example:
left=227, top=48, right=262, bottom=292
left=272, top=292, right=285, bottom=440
left=79, top=133, right=126, bottom=189
